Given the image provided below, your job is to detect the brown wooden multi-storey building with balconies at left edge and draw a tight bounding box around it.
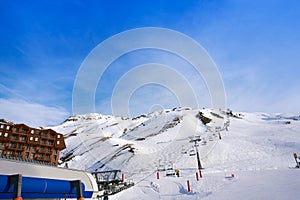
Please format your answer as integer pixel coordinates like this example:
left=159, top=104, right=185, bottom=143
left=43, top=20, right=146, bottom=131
left=0, top=122, right=66, bottom=165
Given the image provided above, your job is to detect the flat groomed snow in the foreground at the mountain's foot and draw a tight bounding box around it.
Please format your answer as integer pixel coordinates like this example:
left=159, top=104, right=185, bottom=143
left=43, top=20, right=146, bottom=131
left=110, top=169, right=300, bottom=200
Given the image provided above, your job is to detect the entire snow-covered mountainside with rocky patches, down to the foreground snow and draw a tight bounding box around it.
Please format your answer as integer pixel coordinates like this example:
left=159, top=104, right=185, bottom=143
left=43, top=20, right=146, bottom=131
left=51, top=108, right=300, bottom=199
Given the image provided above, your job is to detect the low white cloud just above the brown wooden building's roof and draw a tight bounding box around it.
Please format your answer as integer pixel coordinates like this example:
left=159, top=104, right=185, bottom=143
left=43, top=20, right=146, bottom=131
left=0, top=99, right=69, bottom=127
